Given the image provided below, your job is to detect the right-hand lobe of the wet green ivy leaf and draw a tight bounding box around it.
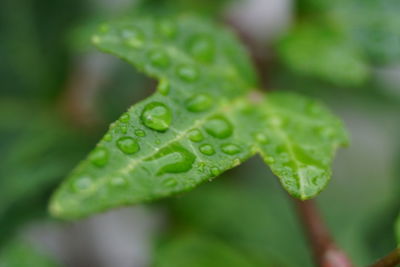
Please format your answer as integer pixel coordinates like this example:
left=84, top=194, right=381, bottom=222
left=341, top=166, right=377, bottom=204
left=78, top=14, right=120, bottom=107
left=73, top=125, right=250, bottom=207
left=258, top=92, right=348, bottom=199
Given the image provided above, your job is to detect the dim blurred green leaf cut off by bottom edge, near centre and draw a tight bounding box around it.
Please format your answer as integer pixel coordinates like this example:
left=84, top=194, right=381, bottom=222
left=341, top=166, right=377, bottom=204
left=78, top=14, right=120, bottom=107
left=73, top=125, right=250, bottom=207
left=153, top=234, right=258, bottom=267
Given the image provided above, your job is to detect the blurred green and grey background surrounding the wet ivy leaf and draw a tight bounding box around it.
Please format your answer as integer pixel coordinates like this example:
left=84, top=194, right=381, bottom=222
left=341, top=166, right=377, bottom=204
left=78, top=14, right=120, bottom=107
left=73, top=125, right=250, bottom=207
left=0, top=0, right=400, bottom=267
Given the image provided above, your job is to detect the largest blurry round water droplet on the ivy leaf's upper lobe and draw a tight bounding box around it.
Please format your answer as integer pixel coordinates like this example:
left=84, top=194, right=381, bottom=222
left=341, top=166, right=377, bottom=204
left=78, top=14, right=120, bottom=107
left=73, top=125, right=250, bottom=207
left=188, top=34, right=215, bottom=62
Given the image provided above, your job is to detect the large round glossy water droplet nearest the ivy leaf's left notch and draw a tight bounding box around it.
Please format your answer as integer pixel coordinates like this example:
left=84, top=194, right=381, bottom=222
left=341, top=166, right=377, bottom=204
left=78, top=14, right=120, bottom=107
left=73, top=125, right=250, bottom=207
left=141, top=102, right=172, bottom=131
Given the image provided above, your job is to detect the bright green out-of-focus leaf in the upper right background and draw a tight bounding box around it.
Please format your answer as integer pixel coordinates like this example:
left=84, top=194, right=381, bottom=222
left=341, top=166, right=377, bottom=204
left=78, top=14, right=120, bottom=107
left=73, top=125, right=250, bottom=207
left=278, top=22, right=369, bottom=86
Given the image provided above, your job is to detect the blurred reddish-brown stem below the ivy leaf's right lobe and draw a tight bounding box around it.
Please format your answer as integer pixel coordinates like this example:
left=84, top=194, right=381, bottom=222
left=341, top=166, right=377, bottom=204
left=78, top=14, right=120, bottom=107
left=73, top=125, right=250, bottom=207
left=295, top=200, right=352, bottom=267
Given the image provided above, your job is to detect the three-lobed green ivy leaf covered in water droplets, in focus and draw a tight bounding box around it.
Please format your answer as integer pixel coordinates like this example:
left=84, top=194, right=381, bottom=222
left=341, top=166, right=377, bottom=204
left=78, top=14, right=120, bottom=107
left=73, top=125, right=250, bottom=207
left=50, top=16, right=346, bottom=218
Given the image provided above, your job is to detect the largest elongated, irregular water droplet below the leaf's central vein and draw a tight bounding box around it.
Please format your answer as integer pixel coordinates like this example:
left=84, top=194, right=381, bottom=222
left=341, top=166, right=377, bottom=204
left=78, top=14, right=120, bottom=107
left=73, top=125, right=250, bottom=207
left=146, top=144, right=196, bottom=175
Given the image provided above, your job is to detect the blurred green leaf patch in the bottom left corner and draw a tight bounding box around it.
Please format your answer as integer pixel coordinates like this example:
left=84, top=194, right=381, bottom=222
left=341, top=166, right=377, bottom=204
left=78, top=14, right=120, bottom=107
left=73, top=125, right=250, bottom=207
left=0, top=240, right=59, bottom=267
